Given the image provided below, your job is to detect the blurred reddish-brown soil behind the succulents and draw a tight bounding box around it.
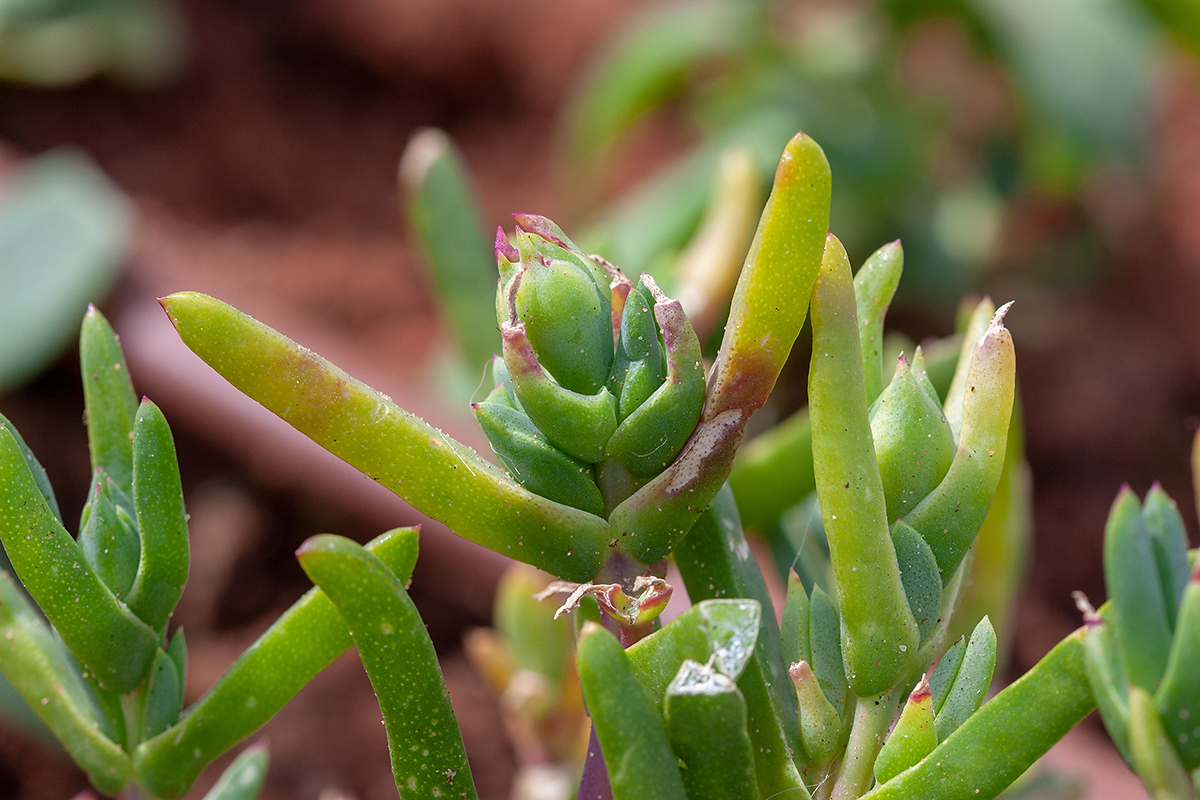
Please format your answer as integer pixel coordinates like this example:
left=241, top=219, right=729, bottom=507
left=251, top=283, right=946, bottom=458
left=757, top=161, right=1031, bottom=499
left=0, top=0, right=1200, bottom=799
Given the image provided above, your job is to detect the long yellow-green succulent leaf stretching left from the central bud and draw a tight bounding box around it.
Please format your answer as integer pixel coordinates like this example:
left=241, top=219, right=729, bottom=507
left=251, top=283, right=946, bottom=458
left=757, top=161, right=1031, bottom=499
left=162, top=293, right=612, bottom=581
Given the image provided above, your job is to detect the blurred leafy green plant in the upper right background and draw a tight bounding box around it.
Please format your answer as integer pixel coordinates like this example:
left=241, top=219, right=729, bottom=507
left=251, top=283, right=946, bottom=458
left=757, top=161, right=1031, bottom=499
left=564, top=0, right=1180, bottom=305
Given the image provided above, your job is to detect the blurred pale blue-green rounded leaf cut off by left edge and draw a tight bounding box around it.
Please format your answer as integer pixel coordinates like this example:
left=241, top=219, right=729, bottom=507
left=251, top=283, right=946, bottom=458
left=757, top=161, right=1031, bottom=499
left=0, top=149, right=133, bottom=389
